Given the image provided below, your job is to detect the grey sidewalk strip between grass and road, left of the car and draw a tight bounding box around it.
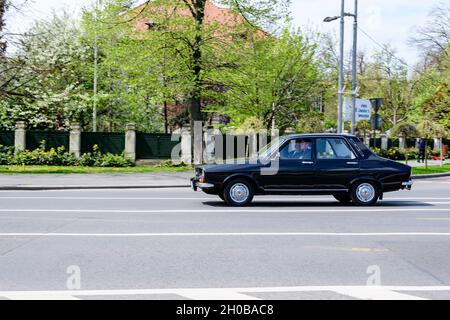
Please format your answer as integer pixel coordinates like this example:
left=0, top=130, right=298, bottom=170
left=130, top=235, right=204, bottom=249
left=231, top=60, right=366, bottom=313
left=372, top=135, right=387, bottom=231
left=0, top=171, right=194, bottom=190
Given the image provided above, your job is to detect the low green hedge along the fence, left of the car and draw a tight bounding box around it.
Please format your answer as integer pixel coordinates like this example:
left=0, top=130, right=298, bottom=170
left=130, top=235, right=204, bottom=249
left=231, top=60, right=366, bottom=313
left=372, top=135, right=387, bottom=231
left=0, top=141, right=135, bottom=167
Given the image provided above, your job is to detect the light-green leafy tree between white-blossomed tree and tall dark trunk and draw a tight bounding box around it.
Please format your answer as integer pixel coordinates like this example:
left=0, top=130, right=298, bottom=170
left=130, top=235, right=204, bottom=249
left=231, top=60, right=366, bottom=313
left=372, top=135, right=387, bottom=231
left=81, top=0, right=168, bottom=132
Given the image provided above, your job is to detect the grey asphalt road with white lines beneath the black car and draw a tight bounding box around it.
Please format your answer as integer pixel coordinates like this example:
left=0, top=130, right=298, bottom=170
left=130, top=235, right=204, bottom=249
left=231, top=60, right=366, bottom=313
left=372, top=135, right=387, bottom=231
left=0, top=178, right=450, bottom=299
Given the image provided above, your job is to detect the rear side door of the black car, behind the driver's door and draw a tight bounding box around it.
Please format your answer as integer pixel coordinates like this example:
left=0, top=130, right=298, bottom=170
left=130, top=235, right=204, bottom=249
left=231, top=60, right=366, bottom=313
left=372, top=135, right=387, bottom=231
left=315, top=137, right=360, bottom=191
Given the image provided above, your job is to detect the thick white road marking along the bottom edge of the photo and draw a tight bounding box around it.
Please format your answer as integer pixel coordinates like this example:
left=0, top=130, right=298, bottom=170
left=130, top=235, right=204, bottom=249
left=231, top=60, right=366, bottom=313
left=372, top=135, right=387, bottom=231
left=0, top=286, right=450, bottom=300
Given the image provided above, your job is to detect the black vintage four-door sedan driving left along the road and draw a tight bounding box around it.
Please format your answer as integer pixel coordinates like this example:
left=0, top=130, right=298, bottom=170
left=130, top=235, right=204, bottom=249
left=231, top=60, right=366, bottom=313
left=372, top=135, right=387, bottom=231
left=191, top=134, right=412, bottom=206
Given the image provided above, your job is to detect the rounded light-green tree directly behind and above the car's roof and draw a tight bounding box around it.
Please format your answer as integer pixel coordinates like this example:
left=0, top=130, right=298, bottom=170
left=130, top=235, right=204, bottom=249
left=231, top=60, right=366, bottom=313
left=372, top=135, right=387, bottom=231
left=213, top=29, right=319, bottom=130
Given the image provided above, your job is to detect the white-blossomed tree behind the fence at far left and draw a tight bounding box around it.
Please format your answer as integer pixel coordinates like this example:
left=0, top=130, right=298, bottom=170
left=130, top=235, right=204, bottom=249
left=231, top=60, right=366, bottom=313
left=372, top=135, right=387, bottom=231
left=0, top=15, right=91, bottom=129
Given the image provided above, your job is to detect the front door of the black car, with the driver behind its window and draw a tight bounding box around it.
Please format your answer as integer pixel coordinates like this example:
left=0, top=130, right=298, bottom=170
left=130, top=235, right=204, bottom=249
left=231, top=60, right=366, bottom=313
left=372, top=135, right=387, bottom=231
left=261, top=138, right=317, bottom=191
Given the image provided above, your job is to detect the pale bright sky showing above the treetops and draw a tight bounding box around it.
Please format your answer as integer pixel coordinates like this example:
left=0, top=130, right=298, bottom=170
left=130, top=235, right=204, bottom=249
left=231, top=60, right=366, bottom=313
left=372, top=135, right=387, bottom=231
left=4, top=0, right=443, bottom=68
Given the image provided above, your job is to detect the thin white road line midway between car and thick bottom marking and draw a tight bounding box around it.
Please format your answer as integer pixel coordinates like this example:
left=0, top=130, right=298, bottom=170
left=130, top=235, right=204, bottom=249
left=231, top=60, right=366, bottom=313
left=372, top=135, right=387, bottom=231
left=0, top=232, right=450, bottom=238
